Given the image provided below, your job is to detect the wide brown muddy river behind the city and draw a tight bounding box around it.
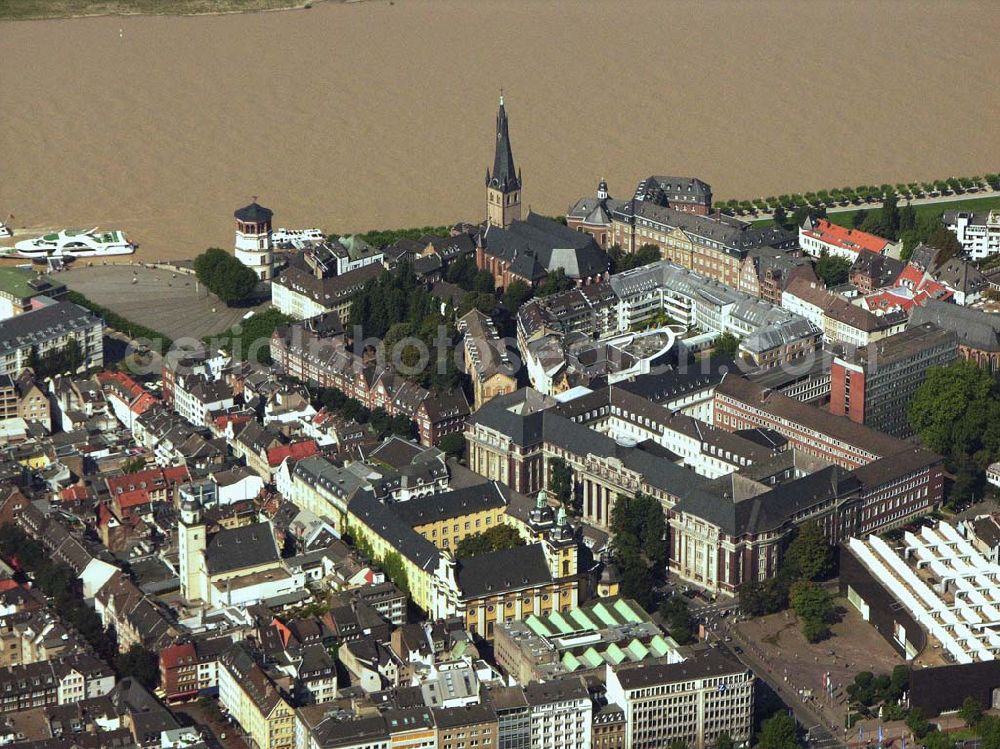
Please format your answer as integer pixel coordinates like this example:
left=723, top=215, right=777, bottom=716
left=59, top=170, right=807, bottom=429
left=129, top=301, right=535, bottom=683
left=0, top=0, right=1000, bottom=260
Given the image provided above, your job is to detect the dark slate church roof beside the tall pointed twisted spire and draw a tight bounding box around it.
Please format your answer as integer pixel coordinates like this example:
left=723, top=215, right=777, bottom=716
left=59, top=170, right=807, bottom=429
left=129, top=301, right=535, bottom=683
left=482, top=213, right=610, bottom=279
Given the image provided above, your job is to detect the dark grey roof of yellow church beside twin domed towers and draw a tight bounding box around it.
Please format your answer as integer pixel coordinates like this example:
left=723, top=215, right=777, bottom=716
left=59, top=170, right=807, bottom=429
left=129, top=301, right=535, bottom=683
left=455, top=544, right=552, bottom=599
